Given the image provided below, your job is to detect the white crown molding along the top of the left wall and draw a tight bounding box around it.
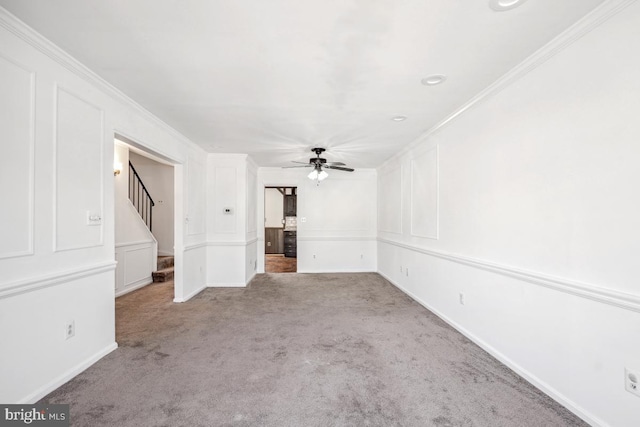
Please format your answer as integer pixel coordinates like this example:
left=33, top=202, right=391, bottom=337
left=0, top=7, right=204, bottom=151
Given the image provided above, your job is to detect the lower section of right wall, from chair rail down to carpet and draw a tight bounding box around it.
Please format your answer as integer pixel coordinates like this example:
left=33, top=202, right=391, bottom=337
left=378, top=240, right=640, bottom=426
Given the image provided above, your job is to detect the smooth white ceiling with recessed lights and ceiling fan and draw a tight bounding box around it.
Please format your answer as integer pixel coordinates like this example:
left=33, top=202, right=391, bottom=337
left=0, top=0, right=603, bottom=168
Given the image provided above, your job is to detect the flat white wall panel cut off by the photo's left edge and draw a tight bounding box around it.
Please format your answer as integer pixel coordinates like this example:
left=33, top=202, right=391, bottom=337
left=0, top=55, right=35, bottom=258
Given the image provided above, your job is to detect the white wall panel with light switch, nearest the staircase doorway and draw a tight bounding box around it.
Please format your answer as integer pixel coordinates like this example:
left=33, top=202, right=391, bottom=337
left=54, top=87, right=104, bottom=251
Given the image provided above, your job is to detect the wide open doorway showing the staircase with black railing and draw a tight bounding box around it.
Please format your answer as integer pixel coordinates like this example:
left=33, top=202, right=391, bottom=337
left=114, top=135, right=176, bottom=297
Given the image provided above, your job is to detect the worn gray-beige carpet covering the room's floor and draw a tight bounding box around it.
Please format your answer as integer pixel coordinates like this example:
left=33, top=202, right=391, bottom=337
left=42, top=273, right=586, bottom=427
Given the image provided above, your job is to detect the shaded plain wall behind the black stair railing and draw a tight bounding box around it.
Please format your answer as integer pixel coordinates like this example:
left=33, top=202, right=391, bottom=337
left=128, top=152, right=175, bottom=255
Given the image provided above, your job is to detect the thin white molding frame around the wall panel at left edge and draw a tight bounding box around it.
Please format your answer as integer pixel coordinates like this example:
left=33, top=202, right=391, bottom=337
left=0, top=53, right=36, bottom=259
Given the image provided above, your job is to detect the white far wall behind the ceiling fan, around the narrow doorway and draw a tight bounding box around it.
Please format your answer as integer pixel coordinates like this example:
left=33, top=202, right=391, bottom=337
left=257, top=168, right=377, bottom=273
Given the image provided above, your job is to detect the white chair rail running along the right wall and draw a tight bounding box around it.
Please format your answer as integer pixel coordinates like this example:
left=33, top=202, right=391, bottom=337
left=378, top=238, right=640, bottom=312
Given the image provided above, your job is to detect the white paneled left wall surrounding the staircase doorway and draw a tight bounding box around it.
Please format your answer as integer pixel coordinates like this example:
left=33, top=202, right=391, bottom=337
left=0, top=9, right=205, bottom=403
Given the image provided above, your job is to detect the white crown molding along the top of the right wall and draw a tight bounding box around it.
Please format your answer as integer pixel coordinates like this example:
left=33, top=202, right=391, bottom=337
left=381, top=0, right=636, bottom=167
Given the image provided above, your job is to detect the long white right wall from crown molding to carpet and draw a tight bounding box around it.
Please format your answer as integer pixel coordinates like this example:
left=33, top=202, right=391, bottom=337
left=378, top=3, right=640, bottom=426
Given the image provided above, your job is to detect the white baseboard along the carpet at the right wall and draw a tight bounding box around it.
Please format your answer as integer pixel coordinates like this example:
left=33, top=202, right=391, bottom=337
left=378, top=272, right=607, bottom=426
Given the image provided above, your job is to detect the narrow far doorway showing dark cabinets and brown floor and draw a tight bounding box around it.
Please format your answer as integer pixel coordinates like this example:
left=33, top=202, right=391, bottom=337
left=264, top=187, right=298, bottom=273
